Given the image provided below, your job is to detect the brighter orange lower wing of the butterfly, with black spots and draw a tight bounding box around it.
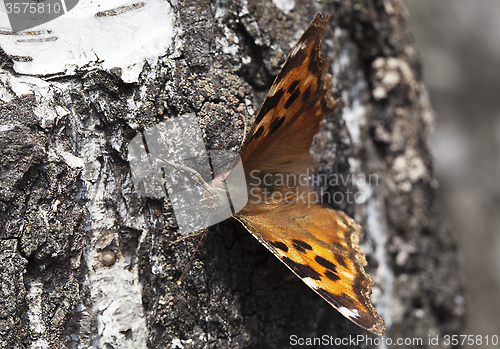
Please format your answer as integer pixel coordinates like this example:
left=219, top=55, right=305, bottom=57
left=235, top=203, right=385, bottom=335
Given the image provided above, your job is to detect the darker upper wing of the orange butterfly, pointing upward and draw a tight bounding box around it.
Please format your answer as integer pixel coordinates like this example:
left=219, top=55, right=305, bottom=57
left=240, top=14, right=338, bottom=173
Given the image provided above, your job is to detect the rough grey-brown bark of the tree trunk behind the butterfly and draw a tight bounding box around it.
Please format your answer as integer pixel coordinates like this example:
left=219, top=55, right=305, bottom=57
left=0, top=0, right=463, bottom=348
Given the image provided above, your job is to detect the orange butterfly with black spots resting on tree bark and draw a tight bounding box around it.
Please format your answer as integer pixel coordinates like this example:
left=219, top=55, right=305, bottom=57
left=229, top=14, right=385, bottom=335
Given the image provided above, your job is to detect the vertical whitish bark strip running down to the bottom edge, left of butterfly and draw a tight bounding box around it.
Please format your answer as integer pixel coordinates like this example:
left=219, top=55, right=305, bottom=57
left=84, top=169, right=148, bottom=349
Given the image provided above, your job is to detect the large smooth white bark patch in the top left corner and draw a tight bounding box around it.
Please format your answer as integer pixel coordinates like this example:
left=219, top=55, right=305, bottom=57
left=0, top=0, right=176, bottom=83
